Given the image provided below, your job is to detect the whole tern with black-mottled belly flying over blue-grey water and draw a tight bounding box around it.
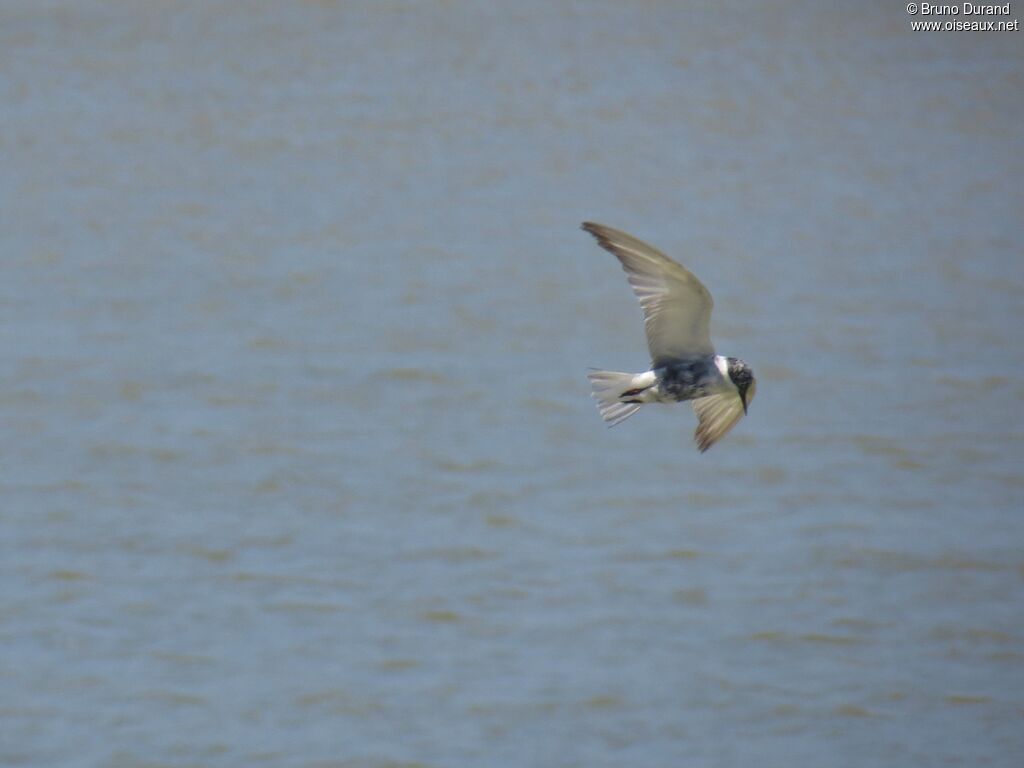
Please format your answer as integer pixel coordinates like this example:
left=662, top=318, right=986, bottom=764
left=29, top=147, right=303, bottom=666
left=583, top=221, right=757, bottom=453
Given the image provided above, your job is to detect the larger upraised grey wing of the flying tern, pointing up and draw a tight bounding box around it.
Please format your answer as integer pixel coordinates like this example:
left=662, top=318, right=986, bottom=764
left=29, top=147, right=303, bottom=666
left=583, top=221, right=715, bottom=368
